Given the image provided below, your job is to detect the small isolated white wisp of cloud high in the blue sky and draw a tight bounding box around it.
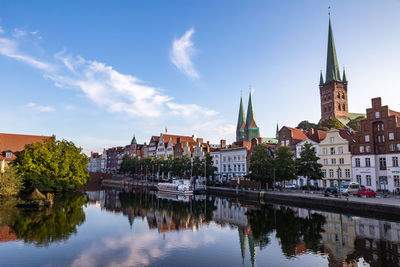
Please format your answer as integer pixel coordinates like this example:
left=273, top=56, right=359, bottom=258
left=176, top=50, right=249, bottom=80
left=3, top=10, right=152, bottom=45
left=170, top=28, right=200, bottom=79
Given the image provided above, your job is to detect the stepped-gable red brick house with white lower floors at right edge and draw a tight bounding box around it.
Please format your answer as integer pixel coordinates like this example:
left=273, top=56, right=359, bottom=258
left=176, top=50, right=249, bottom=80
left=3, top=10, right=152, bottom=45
left=351, top=97, right=400, bottom=191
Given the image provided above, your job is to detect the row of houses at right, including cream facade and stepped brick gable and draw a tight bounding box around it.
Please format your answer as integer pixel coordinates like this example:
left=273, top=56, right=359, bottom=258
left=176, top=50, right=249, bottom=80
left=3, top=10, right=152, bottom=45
left=279, top=97, right=400, bottom=191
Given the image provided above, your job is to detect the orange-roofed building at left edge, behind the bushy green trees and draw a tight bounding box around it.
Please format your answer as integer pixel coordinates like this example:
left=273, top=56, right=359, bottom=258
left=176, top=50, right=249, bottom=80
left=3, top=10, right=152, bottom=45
left=0, top=133, right=55, bottom=171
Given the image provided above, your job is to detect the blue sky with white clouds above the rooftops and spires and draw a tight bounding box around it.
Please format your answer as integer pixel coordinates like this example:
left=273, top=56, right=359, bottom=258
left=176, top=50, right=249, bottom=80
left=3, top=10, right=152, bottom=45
left=0, top=0, right=400, bottom=153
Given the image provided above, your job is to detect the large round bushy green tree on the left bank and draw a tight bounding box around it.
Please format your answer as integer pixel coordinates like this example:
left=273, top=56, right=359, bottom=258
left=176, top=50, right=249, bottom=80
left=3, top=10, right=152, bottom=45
left=14, top=138, right=89, bottom=192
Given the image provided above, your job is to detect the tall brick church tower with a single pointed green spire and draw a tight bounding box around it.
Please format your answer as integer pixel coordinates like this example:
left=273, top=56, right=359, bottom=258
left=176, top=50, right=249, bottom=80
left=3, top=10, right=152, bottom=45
left=319, top=18, right=349, bottom=121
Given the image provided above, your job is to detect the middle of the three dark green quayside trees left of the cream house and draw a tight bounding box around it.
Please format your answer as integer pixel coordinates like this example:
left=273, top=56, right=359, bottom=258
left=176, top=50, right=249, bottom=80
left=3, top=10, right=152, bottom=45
left=274, top=146, right=296, bottom=184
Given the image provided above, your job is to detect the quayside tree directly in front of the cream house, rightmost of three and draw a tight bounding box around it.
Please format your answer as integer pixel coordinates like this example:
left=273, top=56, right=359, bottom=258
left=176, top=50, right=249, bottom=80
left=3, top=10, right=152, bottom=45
left=296, top=143, right=322, bottom=189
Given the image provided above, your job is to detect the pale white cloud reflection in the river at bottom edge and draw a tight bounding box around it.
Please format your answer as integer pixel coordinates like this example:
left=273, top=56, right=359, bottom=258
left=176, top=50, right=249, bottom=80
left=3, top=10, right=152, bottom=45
left=72, top=231, right=216, bottom=266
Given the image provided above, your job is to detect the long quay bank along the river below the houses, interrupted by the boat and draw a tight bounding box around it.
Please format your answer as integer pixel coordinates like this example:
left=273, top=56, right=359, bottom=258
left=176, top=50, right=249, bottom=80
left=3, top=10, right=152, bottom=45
left=102, top=178, right=400, bottom=220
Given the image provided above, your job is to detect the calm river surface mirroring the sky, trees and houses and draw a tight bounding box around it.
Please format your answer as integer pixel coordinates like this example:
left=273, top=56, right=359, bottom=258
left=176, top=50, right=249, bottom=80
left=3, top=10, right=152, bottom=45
left=0, top=190, right=400, bottom=267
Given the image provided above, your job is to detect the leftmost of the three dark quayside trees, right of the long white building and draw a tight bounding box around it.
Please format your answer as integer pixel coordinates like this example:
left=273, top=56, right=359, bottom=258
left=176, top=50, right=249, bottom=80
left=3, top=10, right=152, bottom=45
left=248, top=146, right=274, bottom=188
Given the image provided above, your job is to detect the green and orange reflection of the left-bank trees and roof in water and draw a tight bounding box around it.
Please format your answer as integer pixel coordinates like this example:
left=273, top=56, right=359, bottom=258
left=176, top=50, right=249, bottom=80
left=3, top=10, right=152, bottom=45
left=0, top=194, right=87, bottom=246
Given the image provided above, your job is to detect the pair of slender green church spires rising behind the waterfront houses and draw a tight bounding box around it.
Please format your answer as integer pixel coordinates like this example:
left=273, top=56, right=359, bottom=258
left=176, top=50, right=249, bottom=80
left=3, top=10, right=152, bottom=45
left=236, top=92, right=260, bottom=142
